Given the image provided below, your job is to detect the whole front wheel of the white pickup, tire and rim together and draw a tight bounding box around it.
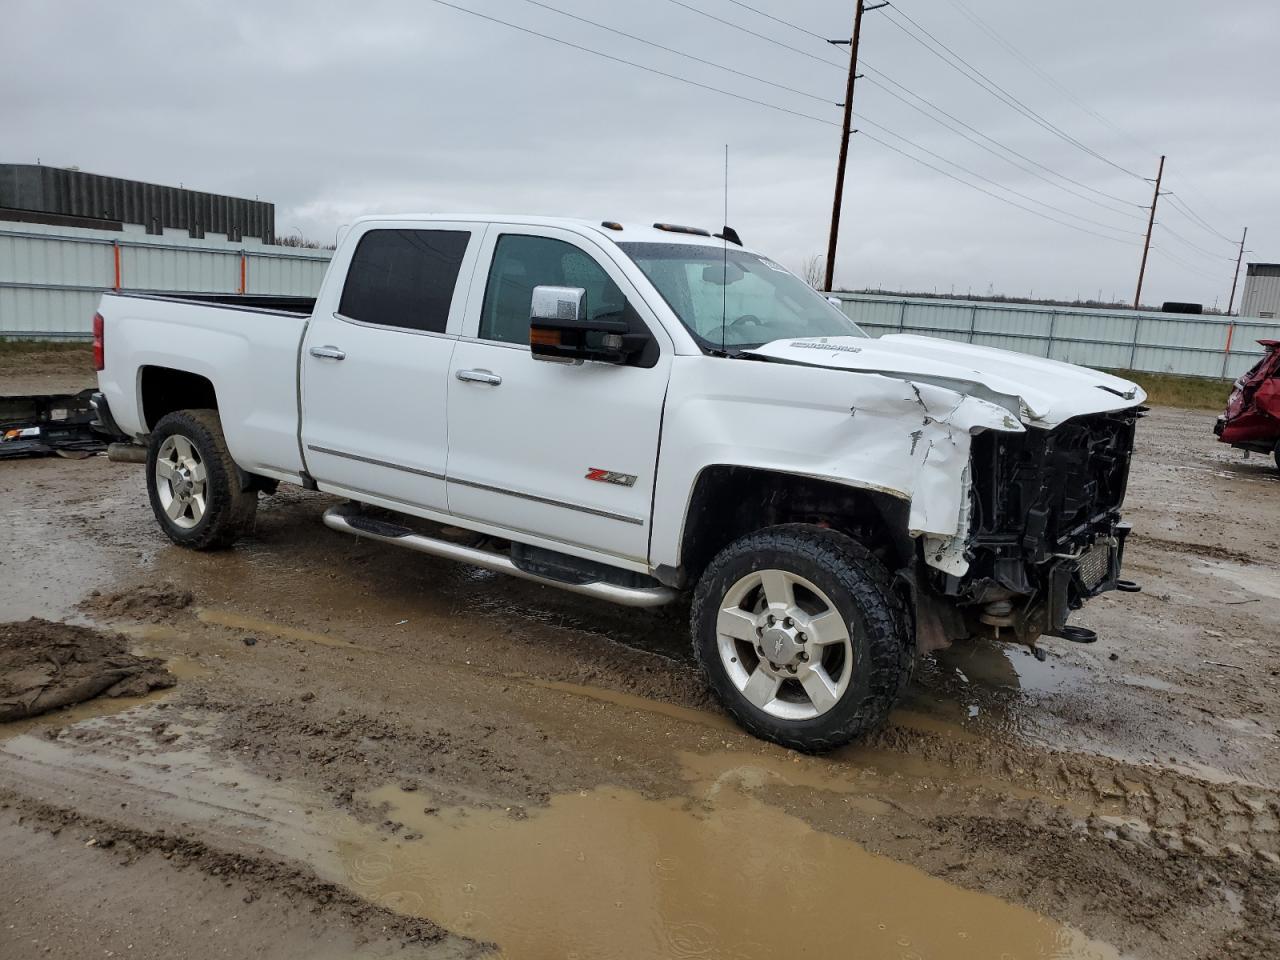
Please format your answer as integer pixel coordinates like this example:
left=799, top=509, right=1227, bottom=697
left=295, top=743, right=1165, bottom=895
left=691, top=524, right=915, bottom=753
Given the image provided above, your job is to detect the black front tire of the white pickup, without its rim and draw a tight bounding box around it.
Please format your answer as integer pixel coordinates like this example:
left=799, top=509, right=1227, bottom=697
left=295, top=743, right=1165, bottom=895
left=690, top=524, right=915, bottom=753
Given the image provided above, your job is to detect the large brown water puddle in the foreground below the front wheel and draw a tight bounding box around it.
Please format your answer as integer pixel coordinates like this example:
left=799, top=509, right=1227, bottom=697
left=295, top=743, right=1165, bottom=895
left=350, top=758, right=1119, bottom=960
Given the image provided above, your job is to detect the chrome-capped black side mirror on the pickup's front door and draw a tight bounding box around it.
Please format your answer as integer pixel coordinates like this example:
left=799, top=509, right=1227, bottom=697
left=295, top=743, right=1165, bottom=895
left=529, top=287, right=648, bottom=364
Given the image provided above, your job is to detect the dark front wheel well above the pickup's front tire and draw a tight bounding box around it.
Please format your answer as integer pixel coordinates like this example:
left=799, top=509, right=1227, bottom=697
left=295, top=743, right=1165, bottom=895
left=680, top=466, right=913, bottom=584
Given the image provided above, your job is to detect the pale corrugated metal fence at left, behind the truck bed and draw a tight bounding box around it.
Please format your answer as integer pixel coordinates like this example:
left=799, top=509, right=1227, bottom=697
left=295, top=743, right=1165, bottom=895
left=0, top=223, right=333, bottom=339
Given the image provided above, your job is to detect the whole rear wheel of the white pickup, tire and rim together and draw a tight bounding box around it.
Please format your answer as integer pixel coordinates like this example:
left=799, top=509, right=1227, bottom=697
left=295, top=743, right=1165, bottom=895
left=147, top=410, right=257, bottom=550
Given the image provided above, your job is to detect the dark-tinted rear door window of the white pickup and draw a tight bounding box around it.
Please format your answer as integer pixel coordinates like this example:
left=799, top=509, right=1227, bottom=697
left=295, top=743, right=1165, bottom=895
left=338, top=230, right=471, bottom=333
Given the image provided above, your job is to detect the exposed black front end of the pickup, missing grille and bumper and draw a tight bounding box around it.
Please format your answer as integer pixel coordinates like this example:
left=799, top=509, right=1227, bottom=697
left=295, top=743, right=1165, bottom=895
left=920, top=407, right=1146, bottom=648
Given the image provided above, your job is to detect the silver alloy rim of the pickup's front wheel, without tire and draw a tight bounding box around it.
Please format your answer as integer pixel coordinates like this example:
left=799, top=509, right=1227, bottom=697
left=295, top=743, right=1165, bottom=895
left=716, top=570, right=854, bottom=721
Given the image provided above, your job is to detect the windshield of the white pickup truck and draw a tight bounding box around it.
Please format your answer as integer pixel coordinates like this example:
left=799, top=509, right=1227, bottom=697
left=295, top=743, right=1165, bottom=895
left=618, top=243, right=867, bottom=349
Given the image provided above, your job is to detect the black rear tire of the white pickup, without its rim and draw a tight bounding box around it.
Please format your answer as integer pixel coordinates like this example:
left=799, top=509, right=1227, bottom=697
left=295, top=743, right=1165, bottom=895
left=147, top=410, right=257, bottom=550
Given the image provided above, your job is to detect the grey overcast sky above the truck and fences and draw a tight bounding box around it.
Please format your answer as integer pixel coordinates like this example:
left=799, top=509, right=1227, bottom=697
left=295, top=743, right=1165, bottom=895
left=0, top=0, right=1280, bottom=307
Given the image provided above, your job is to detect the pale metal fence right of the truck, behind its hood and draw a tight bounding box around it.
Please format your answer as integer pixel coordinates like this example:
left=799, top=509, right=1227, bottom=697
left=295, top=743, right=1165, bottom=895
left=831, top=293, right=1280, bottom=379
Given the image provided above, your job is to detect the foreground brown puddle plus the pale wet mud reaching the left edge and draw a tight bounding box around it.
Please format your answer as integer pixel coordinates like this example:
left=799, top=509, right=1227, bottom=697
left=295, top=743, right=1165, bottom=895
left=0, top=707, right=1119, bottom=960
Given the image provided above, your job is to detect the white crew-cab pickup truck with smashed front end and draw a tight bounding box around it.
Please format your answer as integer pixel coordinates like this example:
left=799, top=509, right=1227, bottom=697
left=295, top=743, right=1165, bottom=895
left=95, top=215, right=1146, bottom=750
